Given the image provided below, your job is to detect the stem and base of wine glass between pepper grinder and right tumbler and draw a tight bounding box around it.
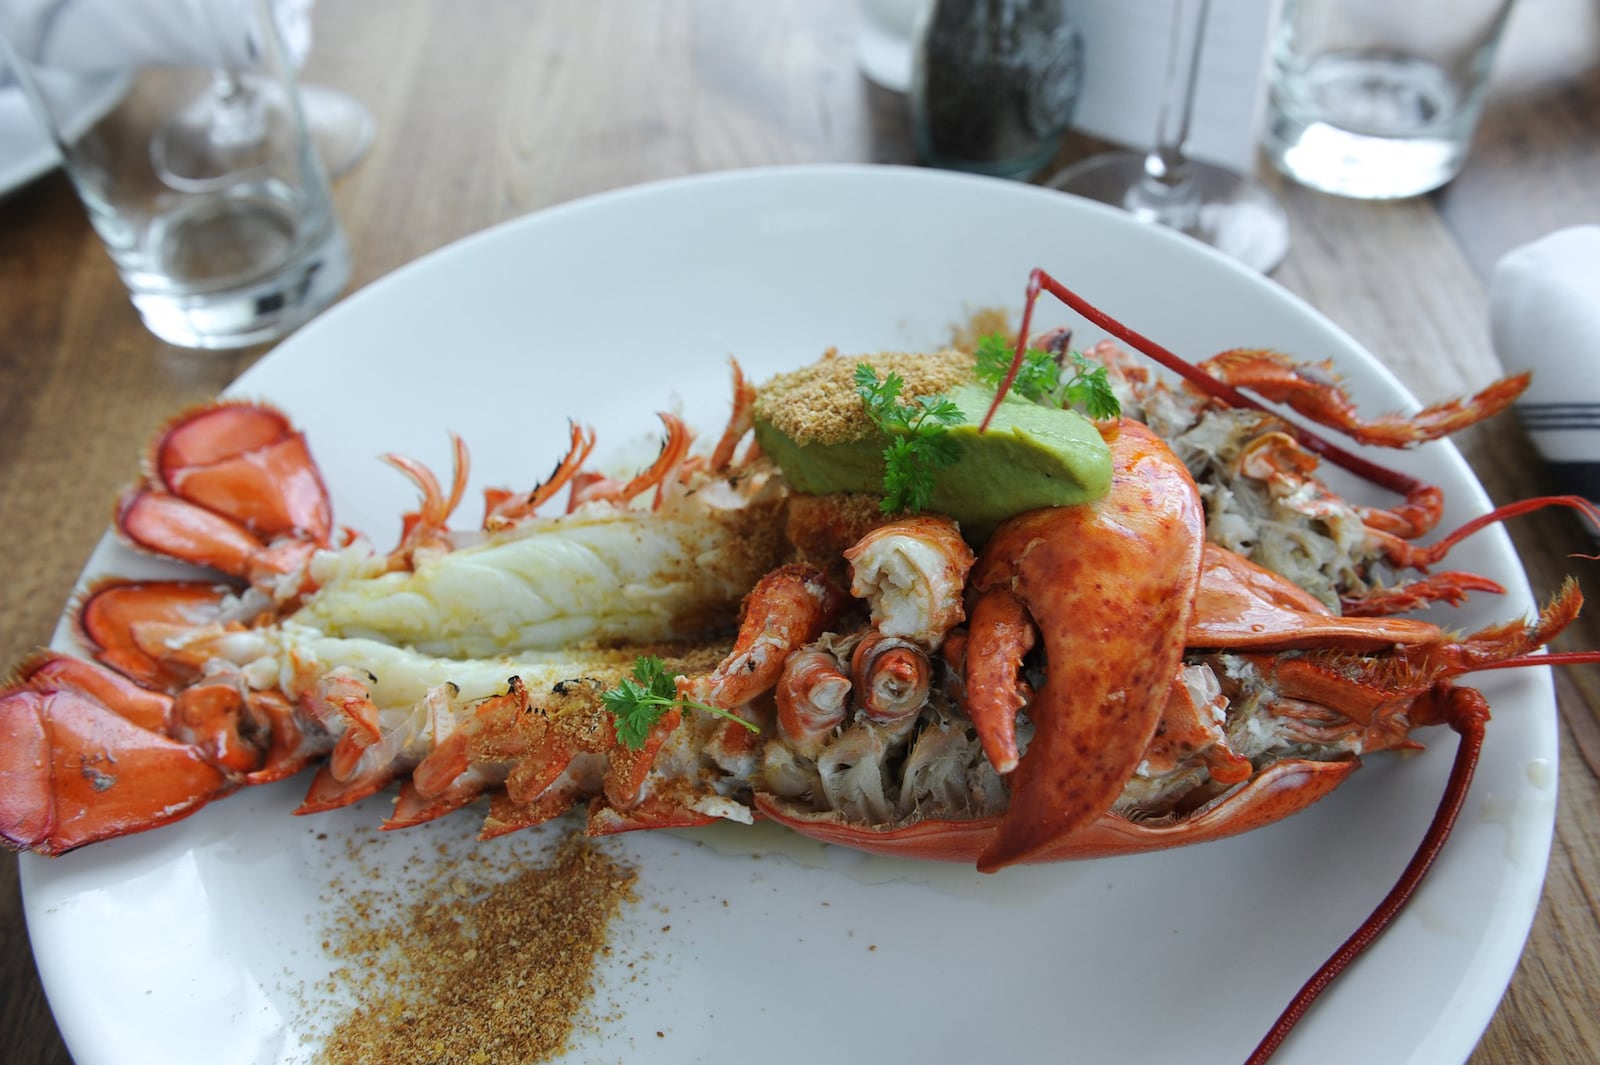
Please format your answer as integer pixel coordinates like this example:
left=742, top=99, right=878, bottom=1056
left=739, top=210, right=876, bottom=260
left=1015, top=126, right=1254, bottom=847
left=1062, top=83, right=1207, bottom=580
left=1046, top=0, right=1290, bottom=273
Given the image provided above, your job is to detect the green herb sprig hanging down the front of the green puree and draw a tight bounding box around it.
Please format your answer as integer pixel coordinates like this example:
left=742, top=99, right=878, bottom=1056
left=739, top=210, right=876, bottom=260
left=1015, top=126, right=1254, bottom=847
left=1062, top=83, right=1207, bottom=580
left=856, top=363, right=966, bottom=513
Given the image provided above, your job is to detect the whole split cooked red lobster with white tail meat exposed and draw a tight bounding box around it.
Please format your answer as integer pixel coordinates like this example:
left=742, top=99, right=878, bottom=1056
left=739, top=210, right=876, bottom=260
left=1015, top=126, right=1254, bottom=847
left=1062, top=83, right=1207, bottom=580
left=0, top=272, right=1582, bottom=1057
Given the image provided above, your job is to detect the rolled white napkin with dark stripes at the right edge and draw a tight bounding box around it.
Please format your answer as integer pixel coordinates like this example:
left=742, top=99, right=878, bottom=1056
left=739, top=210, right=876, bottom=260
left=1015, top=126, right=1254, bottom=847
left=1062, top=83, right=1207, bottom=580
left=1490, top=225, right=1600, bottom=521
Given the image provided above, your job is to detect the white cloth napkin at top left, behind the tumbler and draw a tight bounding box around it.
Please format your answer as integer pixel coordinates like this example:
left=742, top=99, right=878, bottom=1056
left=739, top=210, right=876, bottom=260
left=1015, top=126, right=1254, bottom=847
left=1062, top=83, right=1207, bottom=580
left=0, top=0, right=312, bottom=75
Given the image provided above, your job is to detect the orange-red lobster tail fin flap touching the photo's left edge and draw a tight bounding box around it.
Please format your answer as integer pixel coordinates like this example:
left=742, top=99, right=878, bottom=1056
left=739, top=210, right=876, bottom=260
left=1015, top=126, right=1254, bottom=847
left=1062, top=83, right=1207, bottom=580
left=0, top=688, right=234, bottom=856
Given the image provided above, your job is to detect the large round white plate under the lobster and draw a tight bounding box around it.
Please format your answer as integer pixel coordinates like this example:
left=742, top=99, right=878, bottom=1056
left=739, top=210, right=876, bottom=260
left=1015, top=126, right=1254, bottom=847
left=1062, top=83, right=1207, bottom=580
left=22, top=161, right=1555, bottom=1065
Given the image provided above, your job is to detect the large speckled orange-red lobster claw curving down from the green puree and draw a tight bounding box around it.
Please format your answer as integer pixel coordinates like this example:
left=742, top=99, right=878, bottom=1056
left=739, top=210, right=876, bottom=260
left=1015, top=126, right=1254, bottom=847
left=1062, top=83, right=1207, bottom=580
left=968, top=421, right=1205, bottom=872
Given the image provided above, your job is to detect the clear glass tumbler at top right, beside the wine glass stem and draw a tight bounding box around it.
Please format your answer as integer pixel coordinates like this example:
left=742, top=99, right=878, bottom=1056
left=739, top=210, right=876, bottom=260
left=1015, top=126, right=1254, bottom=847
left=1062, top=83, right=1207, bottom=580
left=1262, top=0, right=1512, bottom=200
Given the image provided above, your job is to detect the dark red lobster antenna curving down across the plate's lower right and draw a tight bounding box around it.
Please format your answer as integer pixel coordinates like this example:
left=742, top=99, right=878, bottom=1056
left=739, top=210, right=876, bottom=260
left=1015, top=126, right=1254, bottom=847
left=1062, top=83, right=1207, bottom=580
left=1245, top=689, right=1488, bottom=1065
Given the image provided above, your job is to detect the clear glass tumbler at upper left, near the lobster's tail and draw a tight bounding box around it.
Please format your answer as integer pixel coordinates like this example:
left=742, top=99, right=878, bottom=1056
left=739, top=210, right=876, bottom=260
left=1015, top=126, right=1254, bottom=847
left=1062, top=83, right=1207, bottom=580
left=0, top=0, right=349, bottom=349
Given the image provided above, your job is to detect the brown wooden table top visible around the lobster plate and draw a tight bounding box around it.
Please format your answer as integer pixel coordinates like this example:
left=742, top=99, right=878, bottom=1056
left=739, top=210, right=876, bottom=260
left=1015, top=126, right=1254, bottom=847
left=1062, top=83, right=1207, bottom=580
left=0, top=0, right=1600, bottom=1065
